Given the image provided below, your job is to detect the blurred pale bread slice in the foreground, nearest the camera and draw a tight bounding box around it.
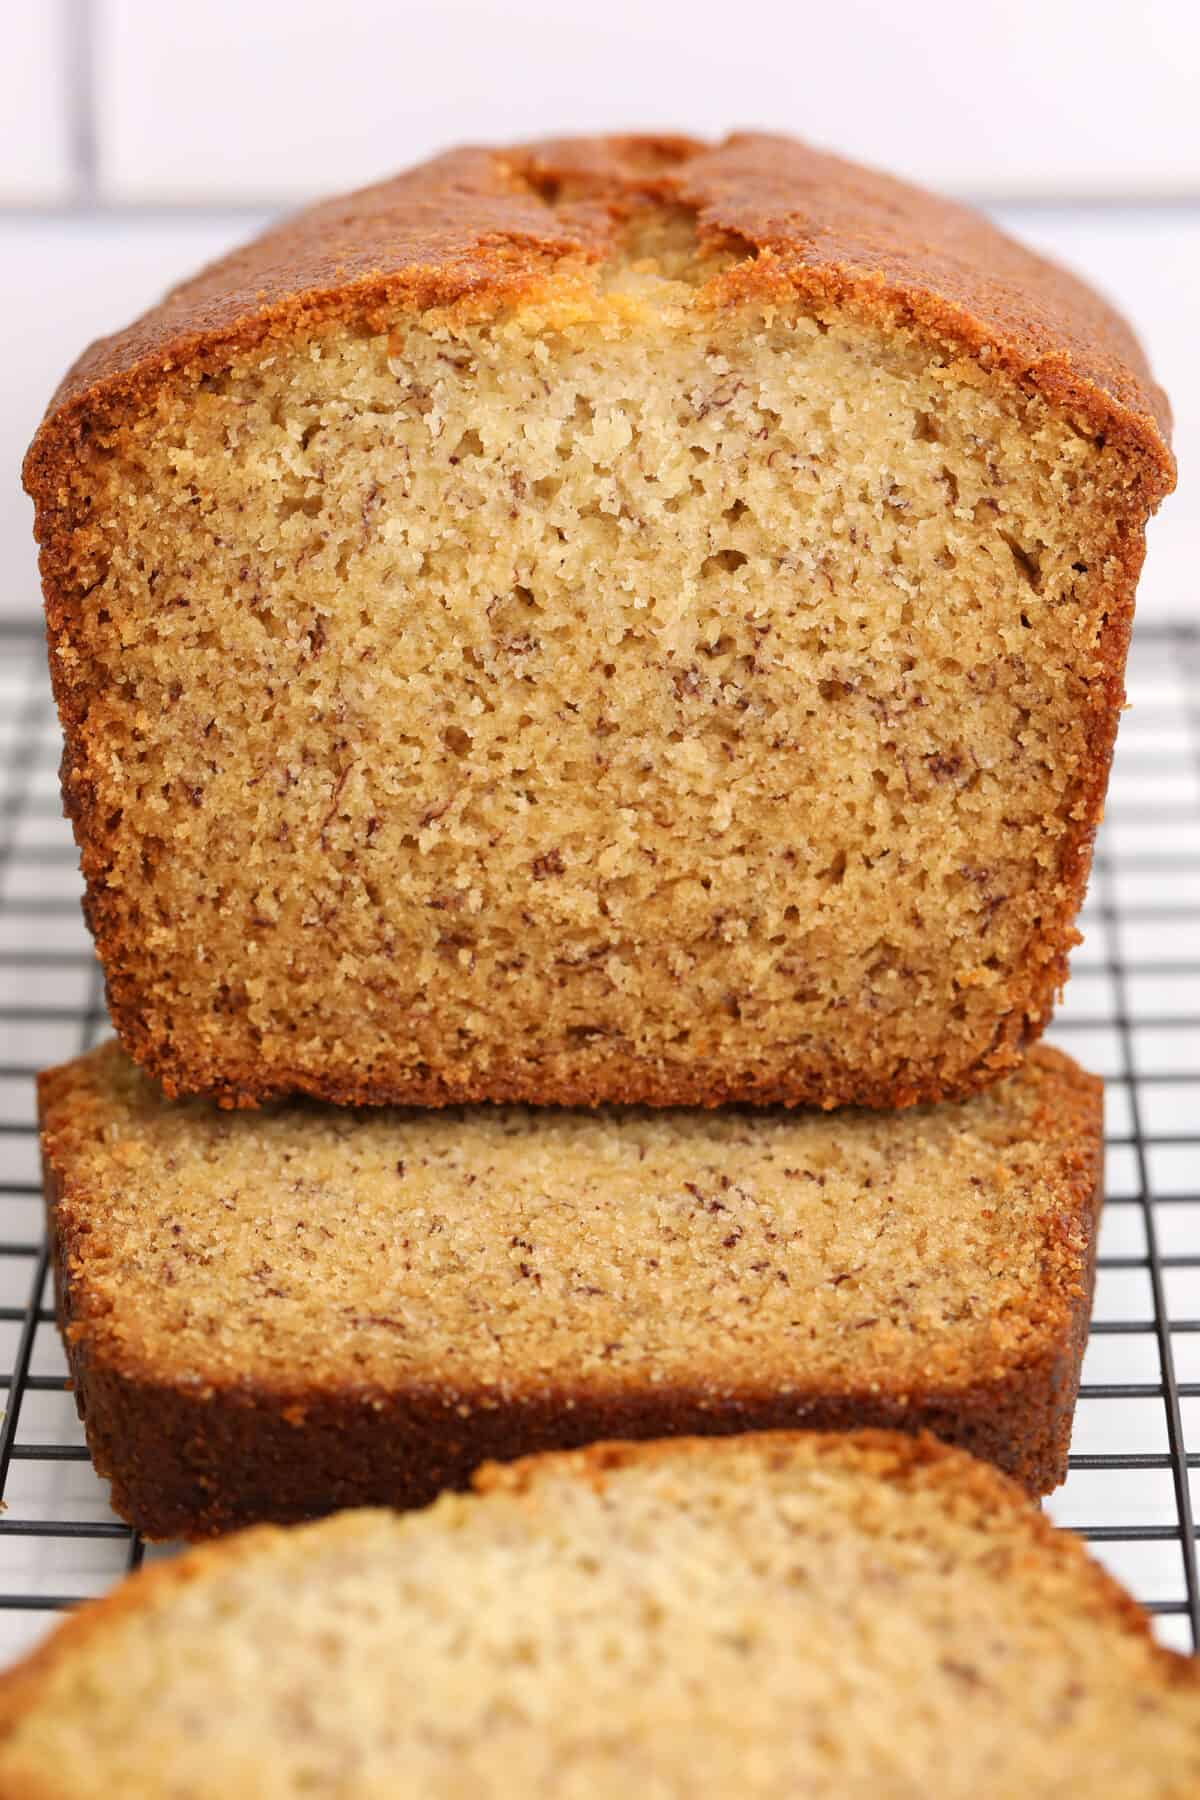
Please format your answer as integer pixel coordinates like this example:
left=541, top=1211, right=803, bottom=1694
left=0, top=1433, right=1200, bottom=1800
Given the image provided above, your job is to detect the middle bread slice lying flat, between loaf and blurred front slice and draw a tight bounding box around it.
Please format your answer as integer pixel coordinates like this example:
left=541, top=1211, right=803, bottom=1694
left=41, top=1044, right=1101, bottom=1537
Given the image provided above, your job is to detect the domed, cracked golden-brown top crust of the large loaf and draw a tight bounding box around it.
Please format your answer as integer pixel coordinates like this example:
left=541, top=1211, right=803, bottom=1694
left=25, top=133, right=1173, bottom=504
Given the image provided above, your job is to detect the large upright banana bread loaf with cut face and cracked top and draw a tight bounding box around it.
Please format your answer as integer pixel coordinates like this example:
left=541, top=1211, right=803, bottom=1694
left=25, top=135, right=1173, bottom=1107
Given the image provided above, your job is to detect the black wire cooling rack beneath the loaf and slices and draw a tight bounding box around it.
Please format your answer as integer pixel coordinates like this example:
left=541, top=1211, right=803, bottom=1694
left=0, top=628, right=1200, bottom=1665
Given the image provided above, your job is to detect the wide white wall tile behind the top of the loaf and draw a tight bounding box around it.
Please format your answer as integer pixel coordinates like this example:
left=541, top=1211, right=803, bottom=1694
left=94, top=0, right=1200, bottom=200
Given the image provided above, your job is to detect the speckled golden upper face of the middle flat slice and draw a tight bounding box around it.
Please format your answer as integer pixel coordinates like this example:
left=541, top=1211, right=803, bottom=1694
left=43, top=1044, right=1101, bottom=1399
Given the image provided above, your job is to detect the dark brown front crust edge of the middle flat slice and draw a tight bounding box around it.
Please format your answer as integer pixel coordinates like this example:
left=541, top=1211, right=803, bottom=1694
left=63, top=1357, right=1078, bottom=1539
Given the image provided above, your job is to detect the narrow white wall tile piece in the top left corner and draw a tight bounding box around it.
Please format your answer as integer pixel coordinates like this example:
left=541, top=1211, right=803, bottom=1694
left=0, top=0, right=74, bottom=205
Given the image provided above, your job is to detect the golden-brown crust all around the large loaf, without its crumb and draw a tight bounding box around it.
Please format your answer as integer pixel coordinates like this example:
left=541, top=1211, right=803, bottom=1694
left=25, top=133, right=1173, bottom=1107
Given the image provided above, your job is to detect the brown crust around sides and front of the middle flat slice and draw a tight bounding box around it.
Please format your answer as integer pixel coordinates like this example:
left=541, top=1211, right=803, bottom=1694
left=40, top=1046, right=1103, bottom=1539
